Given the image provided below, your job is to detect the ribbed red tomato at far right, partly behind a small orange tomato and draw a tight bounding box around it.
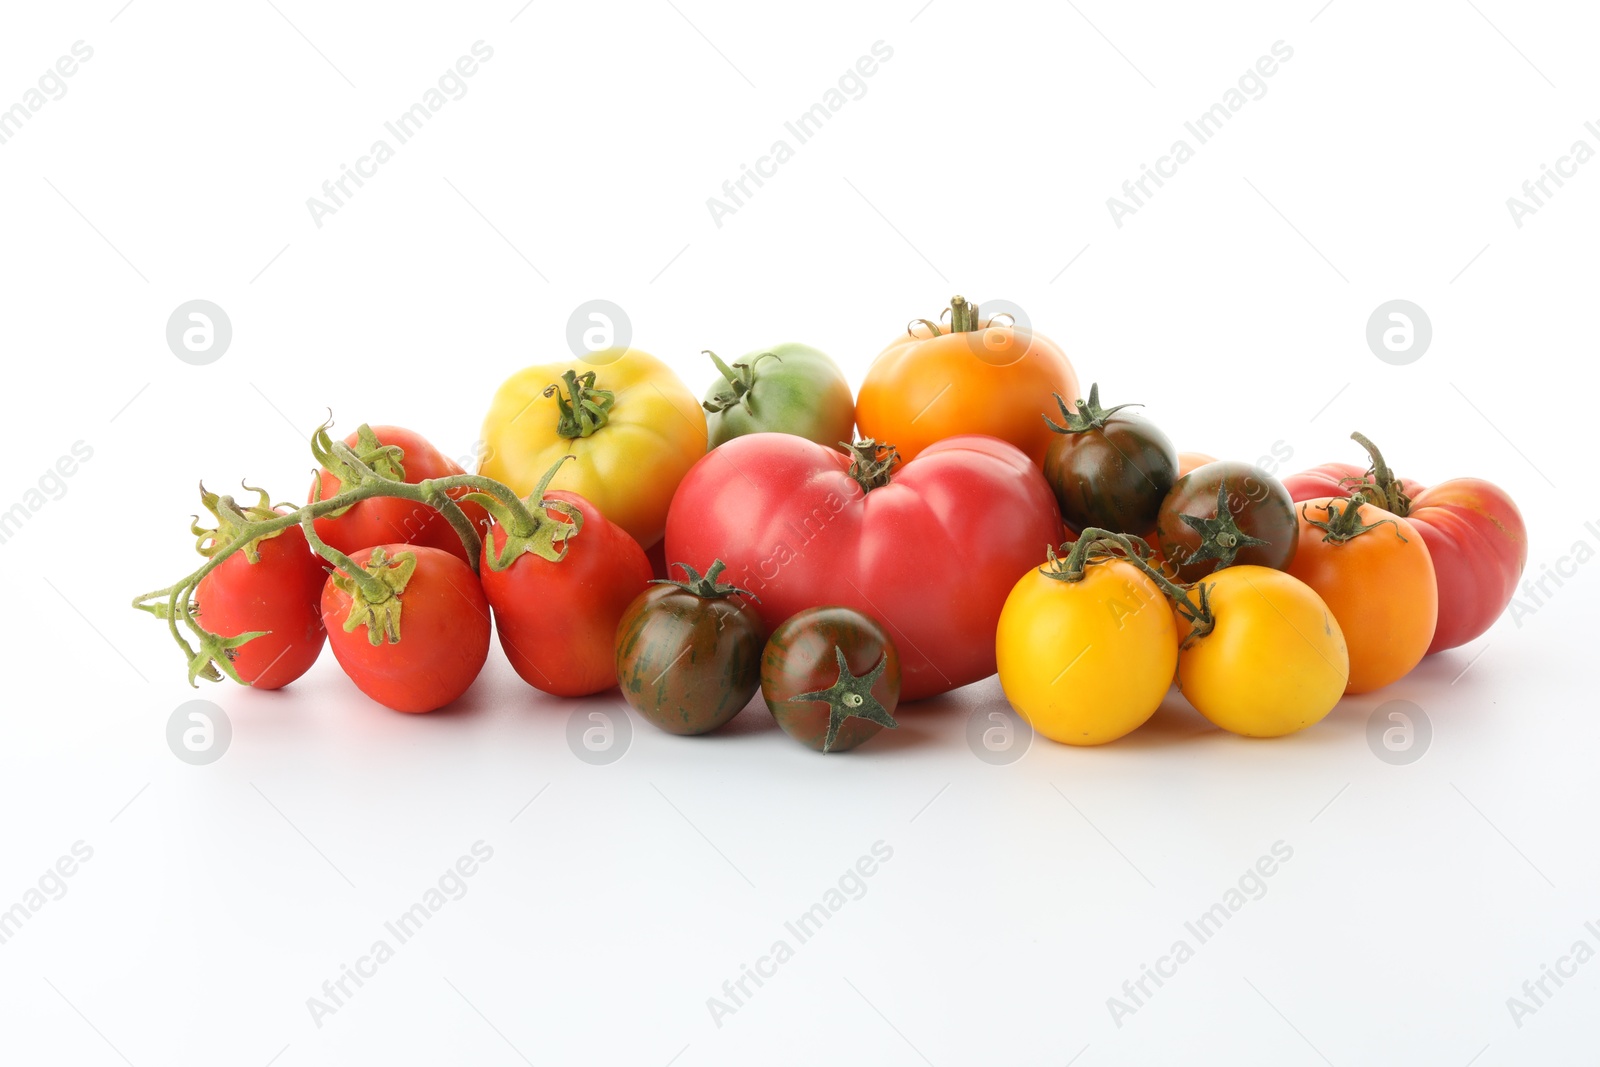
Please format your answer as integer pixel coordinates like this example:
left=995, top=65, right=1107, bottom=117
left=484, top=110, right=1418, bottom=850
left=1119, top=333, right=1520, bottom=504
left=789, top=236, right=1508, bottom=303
left=1283, top=434, right=1528, bottom=654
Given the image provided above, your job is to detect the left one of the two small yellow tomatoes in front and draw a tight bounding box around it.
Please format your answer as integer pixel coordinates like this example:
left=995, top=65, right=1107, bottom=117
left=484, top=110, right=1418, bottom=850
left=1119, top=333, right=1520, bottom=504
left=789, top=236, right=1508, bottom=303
left=995, top=558, right=1178, bottom=745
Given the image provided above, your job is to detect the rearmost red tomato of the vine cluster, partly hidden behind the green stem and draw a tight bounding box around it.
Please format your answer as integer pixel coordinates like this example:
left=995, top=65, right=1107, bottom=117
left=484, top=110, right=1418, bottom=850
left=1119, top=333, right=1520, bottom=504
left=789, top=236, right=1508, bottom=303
left=307, top=426, right=490, bottom=563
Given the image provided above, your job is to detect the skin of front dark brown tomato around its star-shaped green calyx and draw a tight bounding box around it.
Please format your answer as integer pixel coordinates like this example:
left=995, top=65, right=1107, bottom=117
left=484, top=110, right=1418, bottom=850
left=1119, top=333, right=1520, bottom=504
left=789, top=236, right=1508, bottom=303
left=762, top=606, right=901, bottom=752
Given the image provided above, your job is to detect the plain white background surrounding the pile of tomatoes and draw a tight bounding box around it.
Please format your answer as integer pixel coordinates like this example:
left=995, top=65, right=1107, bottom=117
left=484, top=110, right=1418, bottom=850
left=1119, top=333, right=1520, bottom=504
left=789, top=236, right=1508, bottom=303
left=0, top=0, right=1600, bottom=1067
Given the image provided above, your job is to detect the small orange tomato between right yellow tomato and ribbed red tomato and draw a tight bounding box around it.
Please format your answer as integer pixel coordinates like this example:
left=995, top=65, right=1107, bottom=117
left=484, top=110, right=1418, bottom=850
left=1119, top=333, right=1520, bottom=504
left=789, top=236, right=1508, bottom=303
left=1288, top=496, right=1438, bottom=693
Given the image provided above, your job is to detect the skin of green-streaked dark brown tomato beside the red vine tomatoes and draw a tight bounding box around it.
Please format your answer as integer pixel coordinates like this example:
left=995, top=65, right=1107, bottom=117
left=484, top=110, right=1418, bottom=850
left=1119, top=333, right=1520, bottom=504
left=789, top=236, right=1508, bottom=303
left=616, top=585, right=761, bottom=734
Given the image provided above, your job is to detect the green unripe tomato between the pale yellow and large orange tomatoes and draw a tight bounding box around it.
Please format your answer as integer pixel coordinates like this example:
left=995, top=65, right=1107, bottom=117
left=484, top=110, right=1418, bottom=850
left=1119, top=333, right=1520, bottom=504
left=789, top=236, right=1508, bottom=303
left=702, top=342, right=856, bottom=448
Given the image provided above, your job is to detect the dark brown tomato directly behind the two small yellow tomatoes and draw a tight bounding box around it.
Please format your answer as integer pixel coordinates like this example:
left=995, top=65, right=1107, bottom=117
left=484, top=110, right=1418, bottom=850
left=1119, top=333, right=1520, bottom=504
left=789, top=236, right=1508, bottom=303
left=1155, top=459, right=1299, bottom=582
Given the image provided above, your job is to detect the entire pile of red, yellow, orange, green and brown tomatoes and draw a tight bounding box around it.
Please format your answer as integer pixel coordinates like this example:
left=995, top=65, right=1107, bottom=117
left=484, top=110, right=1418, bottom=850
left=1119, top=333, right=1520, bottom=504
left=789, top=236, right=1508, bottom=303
left=136, top=298, right=1526, bottom=752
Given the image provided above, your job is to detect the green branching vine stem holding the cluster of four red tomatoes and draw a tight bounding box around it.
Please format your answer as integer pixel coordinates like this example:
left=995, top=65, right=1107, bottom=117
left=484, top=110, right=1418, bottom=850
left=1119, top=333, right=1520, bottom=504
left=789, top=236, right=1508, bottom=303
left=133, top=424, right=560, bottom=685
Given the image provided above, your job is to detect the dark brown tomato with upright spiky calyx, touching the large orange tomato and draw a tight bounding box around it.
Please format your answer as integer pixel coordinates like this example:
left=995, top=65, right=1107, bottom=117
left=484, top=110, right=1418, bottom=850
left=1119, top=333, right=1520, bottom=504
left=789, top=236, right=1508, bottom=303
left=1045, top=386, right=1178, bottom=534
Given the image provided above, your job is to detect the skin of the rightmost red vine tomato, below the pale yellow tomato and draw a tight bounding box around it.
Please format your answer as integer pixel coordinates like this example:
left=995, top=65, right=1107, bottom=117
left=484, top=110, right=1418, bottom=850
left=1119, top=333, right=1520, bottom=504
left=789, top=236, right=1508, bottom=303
left=478, top=493, right=651, bottom=696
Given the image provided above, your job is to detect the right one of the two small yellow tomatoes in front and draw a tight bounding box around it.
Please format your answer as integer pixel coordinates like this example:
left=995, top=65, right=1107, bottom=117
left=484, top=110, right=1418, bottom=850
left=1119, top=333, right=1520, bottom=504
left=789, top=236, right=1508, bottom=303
left=1178, top=566, right=1350, bottom=737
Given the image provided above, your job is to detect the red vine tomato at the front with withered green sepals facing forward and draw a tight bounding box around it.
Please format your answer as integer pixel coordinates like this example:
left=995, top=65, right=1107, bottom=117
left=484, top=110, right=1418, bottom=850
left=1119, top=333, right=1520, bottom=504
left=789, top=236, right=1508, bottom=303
left=322, top=544, right=490, bottom=712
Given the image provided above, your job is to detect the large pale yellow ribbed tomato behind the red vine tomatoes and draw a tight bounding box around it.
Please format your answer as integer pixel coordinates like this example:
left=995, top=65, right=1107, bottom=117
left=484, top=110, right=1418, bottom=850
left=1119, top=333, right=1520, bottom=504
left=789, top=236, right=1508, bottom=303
left=478, top=349, right=706, bottom=549
